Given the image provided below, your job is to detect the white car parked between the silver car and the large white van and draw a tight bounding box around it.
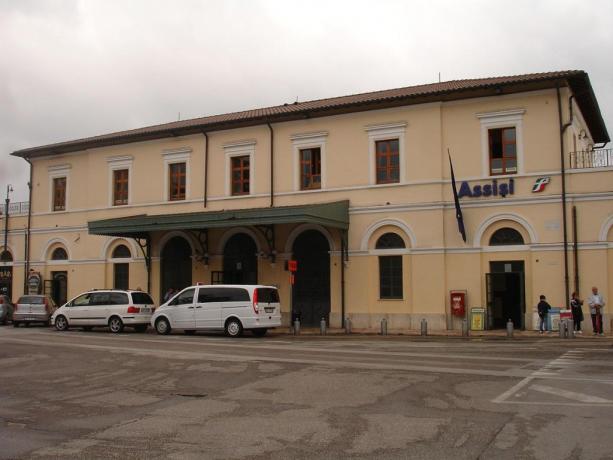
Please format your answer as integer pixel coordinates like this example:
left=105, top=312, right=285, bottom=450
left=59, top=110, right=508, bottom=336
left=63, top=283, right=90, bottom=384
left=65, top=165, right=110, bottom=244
left=51, top=289, right=155, bottom=333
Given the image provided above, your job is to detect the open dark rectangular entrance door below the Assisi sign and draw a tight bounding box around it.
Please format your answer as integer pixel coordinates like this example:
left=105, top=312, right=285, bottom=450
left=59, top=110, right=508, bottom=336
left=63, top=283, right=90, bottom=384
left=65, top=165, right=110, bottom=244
left=485, top=261, right=526, bottom=329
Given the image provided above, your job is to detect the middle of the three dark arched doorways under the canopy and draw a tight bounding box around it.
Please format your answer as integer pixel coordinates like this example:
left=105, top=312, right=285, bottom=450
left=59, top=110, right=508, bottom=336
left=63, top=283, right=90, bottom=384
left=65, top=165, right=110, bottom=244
left=223, top=233, right=258, bottom=284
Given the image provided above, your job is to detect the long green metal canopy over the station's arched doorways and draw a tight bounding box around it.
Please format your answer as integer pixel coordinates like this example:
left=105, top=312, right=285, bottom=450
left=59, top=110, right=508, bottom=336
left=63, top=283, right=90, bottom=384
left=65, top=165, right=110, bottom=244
left=87, top=200, right=349, bottom=238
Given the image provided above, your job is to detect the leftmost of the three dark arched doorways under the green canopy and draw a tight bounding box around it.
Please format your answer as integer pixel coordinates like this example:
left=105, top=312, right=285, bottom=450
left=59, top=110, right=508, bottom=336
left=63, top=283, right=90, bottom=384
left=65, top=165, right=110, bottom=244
left=160, top=236, right=192, bottom=298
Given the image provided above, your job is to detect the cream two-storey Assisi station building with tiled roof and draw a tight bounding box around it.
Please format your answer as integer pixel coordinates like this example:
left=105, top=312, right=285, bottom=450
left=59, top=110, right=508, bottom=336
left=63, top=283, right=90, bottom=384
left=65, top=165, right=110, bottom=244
left=0, top=71, right=613, bottom=331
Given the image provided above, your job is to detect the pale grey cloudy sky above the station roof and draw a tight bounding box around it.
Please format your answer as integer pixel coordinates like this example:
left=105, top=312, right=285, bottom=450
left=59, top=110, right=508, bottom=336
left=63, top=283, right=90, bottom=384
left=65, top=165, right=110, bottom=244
left=0, top=0, right=613, bottom=201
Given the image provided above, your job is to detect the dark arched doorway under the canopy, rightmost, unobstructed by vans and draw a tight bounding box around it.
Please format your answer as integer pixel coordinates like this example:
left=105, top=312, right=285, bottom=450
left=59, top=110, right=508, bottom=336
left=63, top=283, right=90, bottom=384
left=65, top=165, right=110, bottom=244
left=292, top=230, right=330, bottom=326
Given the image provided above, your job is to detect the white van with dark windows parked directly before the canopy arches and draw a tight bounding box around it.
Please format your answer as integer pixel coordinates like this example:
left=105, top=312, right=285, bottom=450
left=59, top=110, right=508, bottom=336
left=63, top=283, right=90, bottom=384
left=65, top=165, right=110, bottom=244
left=151, top=284, right=281, bottom=337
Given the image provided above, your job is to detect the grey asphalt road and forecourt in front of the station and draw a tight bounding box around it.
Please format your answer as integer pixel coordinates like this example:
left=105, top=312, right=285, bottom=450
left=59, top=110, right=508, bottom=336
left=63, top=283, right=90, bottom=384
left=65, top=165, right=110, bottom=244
left=0, top=327, right=613, bottom=459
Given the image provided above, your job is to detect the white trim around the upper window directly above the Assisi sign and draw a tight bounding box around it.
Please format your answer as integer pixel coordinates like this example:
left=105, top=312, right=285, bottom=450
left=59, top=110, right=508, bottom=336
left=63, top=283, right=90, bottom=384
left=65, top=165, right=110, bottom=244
left=477, top=109, right=526, bottom=177
